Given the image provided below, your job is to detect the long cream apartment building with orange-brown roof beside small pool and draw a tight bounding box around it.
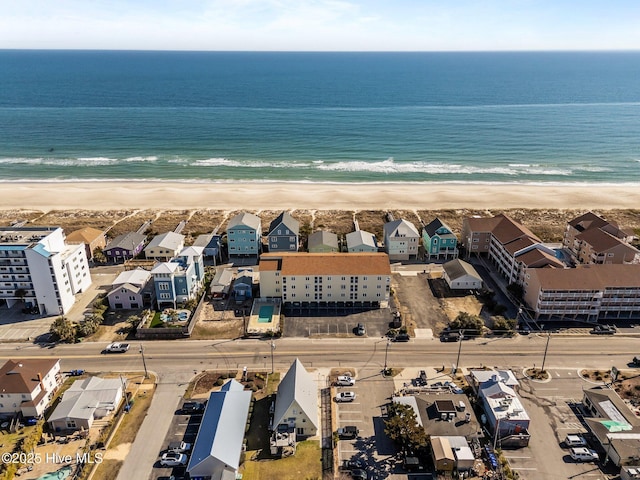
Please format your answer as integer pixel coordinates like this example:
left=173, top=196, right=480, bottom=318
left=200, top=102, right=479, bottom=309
left=260, top=252, right=391, bottom=307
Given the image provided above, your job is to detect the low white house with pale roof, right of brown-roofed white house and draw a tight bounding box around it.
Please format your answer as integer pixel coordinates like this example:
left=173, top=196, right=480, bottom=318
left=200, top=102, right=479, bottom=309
left=48, top=377, right=126, bottom=431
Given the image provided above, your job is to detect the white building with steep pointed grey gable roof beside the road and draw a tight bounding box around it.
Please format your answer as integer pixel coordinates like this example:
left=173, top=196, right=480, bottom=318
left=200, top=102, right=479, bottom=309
left=273, top=358, right=320, bottom=437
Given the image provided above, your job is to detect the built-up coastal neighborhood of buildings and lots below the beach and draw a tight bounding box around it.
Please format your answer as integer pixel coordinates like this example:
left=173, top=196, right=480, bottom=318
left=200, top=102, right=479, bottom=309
left=0, top=210, right=640, bottom=480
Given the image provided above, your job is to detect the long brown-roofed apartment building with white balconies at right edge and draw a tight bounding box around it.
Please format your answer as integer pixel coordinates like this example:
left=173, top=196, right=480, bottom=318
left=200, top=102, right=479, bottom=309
left=523, top=265, right=640, bottom=322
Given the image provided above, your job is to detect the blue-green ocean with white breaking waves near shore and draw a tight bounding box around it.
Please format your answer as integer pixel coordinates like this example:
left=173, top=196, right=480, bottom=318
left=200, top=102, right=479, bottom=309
left=0, top=50, right=640, bottom=185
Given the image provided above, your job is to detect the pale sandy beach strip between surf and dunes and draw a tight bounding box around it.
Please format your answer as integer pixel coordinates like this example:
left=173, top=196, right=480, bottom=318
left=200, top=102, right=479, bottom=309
left=0, top=181, right=640, bottom=211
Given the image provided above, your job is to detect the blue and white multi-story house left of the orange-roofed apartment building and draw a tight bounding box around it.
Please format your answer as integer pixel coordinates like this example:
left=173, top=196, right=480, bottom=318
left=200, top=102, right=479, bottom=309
left=151, top=246, right=204, bottom=310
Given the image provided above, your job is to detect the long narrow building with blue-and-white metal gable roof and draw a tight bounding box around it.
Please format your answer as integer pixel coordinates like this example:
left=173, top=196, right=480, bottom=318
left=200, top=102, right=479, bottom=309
left=187, top=379, right=251, bottom=480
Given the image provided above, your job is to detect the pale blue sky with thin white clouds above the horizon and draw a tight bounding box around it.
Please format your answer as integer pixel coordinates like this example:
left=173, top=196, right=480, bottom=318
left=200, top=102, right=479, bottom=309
left=0, top=0, right=640, bottom=51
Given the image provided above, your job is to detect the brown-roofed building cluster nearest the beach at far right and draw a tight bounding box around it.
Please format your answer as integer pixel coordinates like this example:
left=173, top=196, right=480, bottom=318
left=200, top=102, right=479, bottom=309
left=562, top=212, right=640, bottom=264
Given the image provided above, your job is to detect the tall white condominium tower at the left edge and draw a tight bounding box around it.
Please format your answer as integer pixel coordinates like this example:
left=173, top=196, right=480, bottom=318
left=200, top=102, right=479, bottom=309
left=0, top=227, right=91, bottom=315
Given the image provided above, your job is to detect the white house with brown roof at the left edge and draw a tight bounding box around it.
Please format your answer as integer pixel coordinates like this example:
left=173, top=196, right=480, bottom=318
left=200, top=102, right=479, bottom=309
left=0, top=358, right=62, bottom=417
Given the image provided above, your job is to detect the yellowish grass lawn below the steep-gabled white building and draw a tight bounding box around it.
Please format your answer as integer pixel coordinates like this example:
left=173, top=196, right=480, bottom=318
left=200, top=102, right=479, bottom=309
left=242, top=440, right=322, bottom=480
